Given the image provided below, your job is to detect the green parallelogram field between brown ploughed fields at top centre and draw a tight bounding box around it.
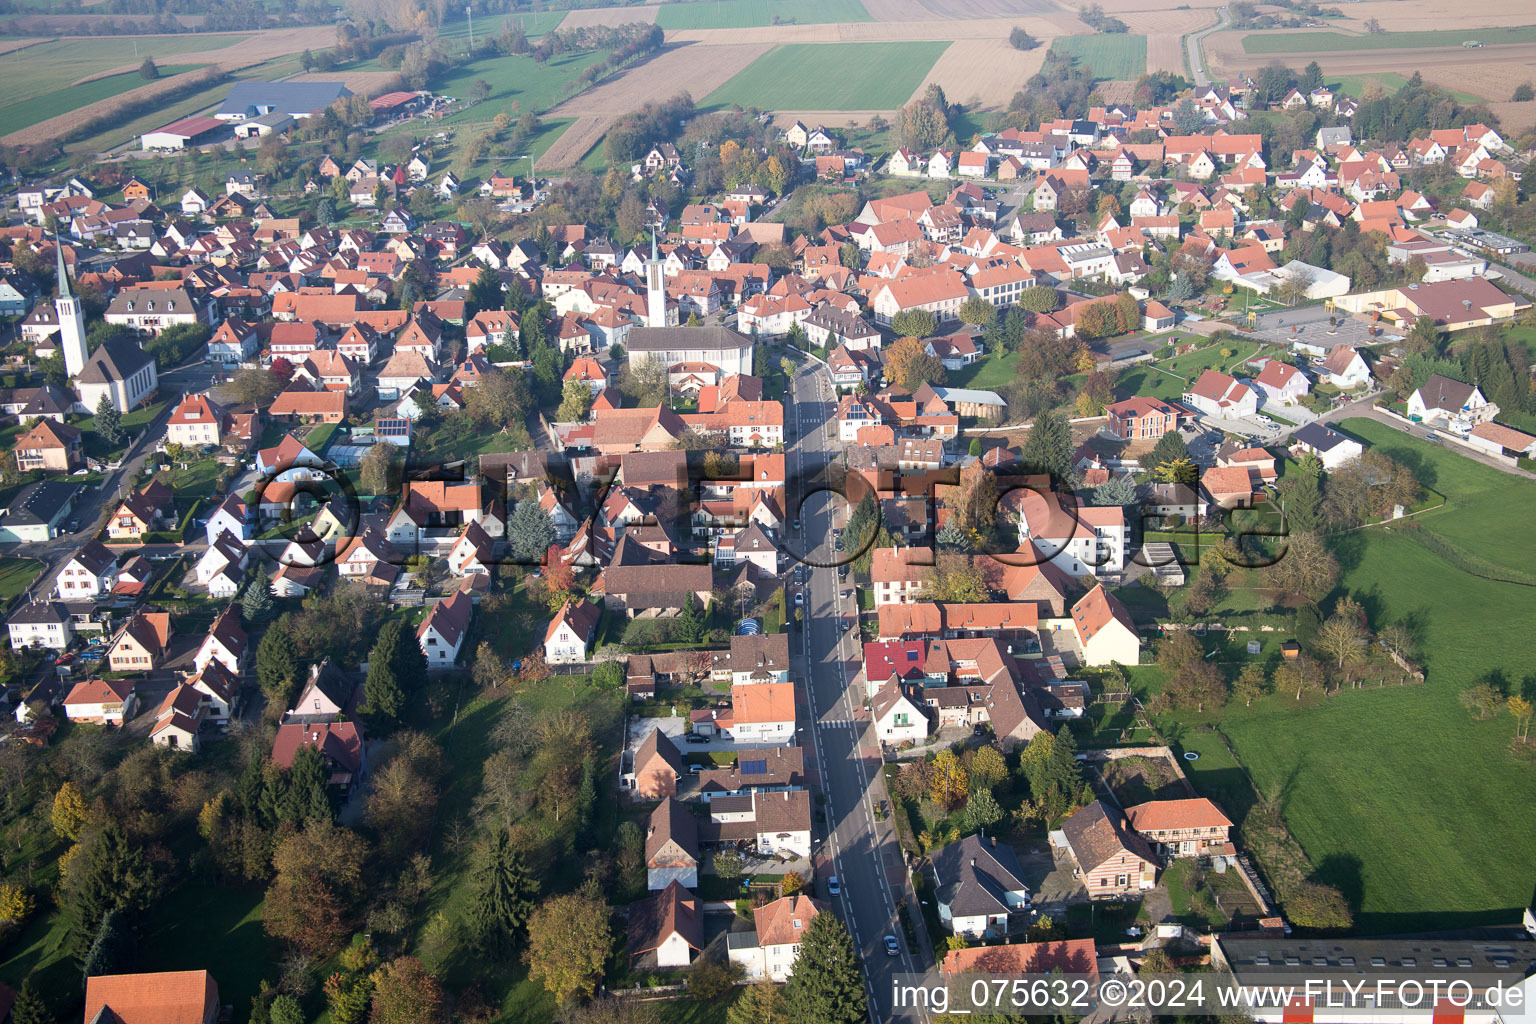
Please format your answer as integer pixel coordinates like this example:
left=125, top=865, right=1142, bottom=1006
left=703, top=41, right=949, bottom=111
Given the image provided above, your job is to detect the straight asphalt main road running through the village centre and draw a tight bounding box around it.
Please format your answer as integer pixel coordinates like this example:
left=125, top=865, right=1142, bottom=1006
left=790, top=364, right=922, bottom=1024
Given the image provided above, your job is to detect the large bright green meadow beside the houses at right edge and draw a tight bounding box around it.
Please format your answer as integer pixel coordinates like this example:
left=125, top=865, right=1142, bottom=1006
left=1155, top=419, right=1536, bottom=933
